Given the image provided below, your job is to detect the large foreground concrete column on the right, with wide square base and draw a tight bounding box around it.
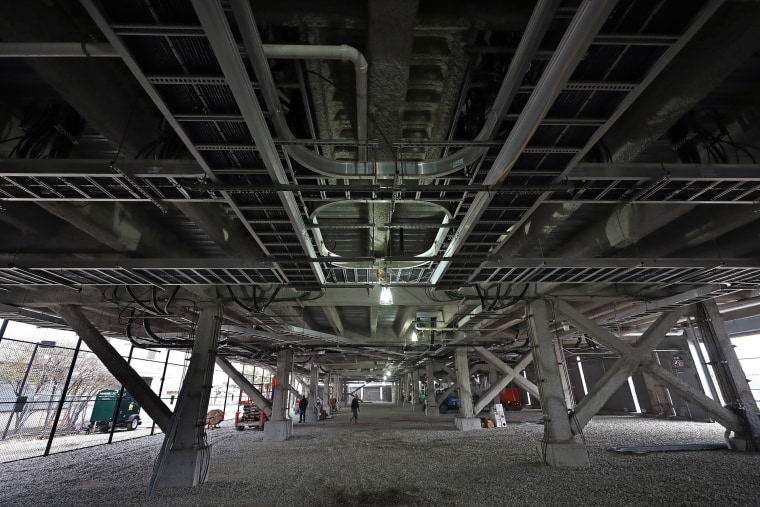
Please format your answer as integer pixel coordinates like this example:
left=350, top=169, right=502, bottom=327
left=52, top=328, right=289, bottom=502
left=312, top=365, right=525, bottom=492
left=528, top=300, right=589, bottom=466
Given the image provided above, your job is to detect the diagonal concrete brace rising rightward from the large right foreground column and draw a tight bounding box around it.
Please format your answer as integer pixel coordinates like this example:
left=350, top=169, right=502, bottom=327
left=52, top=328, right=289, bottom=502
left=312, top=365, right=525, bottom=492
left=573, top=310, right=682, bottom=432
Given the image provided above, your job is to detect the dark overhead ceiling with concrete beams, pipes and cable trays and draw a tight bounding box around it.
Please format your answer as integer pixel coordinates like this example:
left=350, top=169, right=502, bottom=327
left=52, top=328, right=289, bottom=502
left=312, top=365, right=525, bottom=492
left=0, top=0, right=760, bottom=379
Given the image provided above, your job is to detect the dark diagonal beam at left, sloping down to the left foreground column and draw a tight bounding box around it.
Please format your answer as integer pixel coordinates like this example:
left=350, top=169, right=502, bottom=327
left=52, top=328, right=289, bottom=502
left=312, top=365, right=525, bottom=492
left=58, top=305, right=172, bottom=433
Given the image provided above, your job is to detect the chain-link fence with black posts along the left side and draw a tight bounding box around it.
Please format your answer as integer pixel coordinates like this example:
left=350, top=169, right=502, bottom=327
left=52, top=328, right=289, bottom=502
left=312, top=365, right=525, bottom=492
left=0, top=338, right=263, bottom=462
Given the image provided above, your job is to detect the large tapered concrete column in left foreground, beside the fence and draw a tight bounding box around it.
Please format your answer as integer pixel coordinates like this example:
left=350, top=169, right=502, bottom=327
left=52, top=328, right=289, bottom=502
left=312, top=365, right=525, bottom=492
left=149, top=303, right=224, bottom=494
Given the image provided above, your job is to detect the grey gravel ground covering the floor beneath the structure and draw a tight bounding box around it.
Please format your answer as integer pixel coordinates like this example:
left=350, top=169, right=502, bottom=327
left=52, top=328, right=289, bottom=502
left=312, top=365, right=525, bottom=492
left=0, top=404, right=760, bottom=507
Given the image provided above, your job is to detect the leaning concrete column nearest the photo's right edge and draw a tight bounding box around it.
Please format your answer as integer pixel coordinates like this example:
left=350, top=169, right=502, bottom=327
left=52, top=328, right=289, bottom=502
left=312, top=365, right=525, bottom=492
left=697, top=299, right=760, bottom=451
